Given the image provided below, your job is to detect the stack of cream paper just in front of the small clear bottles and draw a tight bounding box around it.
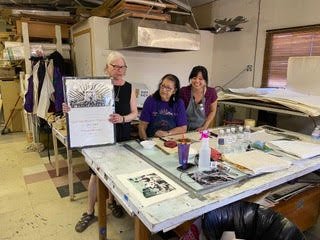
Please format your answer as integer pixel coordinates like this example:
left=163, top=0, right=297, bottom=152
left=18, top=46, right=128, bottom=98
left=223, top=150, right=291, bottom=175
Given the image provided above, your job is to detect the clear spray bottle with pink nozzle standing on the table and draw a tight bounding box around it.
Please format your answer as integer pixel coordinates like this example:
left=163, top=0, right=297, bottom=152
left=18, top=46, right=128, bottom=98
left=198, top=130, right=211, bottom=171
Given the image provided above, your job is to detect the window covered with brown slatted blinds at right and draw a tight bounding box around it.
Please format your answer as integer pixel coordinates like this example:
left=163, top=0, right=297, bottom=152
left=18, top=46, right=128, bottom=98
left=262, top=25, right=320, bottom=87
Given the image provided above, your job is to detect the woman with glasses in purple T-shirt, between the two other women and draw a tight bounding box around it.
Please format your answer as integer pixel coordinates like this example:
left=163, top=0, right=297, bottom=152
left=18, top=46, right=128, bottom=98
left=139, top=74, right=187, bottom=139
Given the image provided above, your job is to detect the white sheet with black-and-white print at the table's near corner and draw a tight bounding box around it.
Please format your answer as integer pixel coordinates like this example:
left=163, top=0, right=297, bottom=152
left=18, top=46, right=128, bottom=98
left=117, top=168, right=187, bottom=206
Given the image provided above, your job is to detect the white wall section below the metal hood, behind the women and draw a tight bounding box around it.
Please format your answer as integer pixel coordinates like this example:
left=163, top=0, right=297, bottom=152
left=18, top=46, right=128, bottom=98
left=121, top=31, right=214, bottom=92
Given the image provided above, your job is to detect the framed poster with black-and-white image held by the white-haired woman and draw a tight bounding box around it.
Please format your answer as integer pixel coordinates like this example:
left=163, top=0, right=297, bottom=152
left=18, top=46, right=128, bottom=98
left=64, top=77, right=115, bottom=148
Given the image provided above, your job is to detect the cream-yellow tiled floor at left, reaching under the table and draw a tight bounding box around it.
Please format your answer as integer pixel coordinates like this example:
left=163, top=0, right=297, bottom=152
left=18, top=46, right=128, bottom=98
left=0, top=133, right=320, bottom=240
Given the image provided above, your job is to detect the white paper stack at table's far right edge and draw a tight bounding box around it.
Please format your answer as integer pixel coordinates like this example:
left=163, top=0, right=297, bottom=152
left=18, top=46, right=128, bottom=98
left=268, top=140, right=320, bottom=159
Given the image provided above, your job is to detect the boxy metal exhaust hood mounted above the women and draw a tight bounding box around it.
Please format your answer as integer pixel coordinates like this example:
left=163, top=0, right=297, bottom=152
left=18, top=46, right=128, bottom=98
left=109, top=18, right=200, bottom=51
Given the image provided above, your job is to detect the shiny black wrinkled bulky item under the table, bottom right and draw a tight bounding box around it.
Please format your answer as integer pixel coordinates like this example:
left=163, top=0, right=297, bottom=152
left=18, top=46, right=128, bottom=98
left=202, top=202, right=305, bottom=240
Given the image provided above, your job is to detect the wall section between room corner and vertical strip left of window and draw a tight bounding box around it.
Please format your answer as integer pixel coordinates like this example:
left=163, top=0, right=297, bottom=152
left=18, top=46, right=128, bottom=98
left=212, top=0, right=258, bottom=87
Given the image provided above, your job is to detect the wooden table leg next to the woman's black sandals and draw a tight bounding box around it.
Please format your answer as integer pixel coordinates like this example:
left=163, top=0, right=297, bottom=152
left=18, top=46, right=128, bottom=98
left=98, top=179, right=108, bottom=240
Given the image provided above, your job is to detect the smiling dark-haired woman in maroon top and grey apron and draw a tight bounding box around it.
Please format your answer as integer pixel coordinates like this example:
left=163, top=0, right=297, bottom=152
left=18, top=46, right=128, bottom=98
left=180, top=66, right=218, bottom=131
